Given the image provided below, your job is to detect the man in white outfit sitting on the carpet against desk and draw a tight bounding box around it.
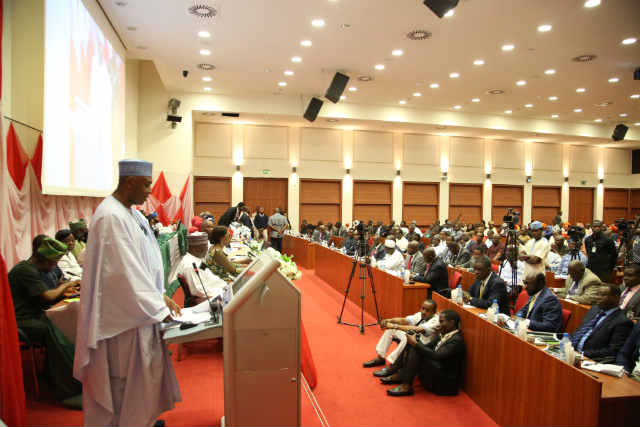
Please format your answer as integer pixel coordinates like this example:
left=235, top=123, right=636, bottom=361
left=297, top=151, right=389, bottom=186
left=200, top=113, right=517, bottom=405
left=362, top=300, right=438, bottom=368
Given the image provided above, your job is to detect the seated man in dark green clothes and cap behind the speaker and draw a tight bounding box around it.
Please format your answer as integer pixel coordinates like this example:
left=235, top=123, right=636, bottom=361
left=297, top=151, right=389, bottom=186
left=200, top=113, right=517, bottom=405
left=9, top=237, right=82, bottom=408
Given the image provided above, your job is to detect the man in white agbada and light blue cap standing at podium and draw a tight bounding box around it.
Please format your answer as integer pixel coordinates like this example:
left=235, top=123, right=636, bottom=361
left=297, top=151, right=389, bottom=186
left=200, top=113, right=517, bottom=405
left=73, top=160, right=181, bottom=426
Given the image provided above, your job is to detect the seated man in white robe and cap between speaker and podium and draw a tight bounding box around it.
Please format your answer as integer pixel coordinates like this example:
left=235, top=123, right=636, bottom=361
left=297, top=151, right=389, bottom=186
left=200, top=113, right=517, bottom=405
left=176, top=232, right=227, bottom=302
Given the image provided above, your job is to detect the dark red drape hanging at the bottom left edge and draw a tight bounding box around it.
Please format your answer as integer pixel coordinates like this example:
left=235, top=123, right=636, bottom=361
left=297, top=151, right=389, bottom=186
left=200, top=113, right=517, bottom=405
left=0, top=255, right=26, bottom=426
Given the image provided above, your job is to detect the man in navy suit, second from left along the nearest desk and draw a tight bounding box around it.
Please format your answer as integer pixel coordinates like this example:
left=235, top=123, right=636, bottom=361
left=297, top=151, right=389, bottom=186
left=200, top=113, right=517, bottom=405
left=518, top=273, right=562, bottom=332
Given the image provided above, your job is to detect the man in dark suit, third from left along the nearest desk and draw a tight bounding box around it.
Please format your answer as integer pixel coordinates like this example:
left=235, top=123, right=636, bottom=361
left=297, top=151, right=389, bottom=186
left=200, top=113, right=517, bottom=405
left=571, top=283, right=633, bottom=363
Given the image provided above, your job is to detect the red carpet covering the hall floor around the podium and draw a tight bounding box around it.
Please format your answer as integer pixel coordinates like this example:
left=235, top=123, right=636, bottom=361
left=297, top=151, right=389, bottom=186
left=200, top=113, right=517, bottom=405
left=26, top=269, right=495, bottom=426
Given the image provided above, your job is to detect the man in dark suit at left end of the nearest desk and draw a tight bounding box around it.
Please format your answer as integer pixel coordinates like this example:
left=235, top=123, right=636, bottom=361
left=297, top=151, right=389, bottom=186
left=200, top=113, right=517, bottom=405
left=462, top=256, right=509, bottom=314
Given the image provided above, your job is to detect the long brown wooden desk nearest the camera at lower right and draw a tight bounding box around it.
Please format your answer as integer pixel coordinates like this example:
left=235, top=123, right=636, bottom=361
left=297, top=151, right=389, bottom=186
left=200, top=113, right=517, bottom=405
left=433, top=294, right=640, bottom=426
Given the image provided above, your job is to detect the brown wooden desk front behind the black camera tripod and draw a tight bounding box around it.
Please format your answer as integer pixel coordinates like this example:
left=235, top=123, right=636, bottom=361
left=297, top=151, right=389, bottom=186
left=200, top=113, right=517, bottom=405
left=315, top=245, right=430, bottom=319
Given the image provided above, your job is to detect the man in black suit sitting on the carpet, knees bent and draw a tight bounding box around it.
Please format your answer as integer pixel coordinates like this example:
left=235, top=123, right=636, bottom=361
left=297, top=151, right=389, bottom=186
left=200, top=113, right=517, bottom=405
left=380, top=310, right=466, bottom=396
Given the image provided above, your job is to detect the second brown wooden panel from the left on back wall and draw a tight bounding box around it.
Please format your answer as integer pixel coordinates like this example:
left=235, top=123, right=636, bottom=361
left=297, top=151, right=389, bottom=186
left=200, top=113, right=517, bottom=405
left=243, top=178, right=289, bottom=216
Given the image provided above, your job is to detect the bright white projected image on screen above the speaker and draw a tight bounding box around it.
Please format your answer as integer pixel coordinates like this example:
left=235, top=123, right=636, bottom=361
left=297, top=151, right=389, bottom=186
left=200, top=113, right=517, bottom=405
left=43, top=0, right=125, bottom=194
